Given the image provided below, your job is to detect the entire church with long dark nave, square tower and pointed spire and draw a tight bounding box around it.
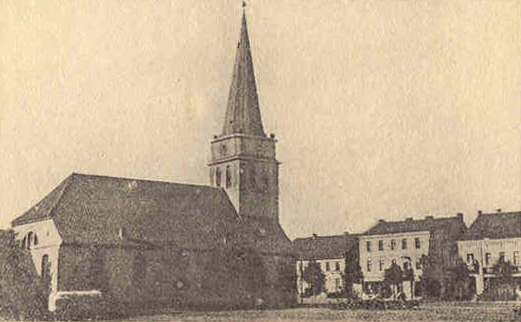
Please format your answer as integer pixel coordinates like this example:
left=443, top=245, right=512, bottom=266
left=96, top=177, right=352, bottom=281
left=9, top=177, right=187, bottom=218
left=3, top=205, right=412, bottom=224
left=11, top=11, right=296, bottom=311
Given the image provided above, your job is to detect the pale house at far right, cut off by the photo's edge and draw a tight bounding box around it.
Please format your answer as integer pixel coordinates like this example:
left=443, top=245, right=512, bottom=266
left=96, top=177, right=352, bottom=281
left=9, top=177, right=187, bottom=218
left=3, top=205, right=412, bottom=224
left=458, top=211, right=521, bottom=294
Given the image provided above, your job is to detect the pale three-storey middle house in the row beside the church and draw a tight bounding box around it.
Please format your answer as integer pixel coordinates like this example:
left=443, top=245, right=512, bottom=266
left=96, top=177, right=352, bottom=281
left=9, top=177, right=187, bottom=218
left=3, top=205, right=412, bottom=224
left=359, top=214, right=466, bottom=299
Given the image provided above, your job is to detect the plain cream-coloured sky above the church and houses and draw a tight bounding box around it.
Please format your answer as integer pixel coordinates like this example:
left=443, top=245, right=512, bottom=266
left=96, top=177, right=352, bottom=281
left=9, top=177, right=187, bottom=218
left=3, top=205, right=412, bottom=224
left=0, top=0, right=521, bottom=239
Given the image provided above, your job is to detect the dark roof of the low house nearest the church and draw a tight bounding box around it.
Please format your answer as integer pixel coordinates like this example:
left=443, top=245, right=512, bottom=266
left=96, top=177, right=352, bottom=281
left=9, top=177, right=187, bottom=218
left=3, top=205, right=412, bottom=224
left=293, top=234, right=358, bottom=259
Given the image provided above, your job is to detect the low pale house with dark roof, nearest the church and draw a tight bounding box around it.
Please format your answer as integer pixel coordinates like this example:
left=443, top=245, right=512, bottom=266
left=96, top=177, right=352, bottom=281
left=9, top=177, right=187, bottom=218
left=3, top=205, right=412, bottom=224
left=293, top=233, right=361, bottom=297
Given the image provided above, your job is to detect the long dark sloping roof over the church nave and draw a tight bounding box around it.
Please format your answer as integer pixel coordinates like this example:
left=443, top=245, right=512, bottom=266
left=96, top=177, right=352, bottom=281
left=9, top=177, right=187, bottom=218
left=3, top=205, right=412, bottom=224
left=12, top=174, right=287, bottom=252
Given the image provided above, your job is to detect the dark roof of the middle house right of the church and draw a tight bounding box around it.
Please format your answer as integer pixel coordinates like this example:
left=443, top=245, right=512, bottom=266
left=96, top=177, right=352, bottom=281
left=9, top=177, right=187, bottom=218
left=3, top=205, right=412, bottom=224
left=363, top=216, right=465, bottom=235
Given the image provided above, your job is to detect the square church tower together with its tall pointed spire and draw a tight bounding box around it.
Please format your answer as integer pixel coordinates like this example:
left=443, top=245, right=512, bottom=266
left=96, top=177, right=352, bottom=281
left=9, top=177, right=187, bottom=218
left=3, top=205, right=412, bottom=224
left=209, top=10, right=279, bottom=222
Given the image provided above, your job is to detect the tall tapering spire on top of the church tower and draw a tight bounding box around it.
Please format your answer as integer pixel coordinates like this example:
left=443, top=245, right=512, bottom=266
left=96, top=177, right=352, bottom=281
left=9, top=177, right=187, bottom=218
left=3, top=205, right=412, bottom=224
left=222, top=7, right=266, bottom=136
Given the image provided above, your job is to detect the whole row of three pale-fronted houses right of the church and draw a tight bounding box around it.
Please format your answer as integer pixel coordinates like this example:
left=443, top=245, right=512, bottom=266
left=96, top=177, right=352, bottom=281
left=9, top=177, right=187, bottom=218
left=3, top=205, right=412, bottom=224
left=294, top=210, right=521, bottom=298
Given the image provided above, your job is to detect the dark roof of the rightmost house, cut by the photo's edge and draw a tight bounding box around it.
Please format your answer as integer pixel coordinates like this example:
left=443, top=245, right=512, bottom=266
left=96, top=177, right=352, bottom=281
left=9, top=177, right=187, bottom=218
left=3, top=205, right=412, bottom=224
left=461, top=211, right=521, bottom=240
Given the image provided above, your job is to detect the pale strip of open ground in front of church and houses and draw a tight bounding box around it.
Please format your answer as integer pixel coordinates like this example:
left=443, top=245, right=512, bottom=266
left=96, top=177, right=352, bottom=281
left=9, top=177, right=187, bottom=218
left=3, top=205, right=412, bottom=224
left=118, top=303, right=519, bottom=322
